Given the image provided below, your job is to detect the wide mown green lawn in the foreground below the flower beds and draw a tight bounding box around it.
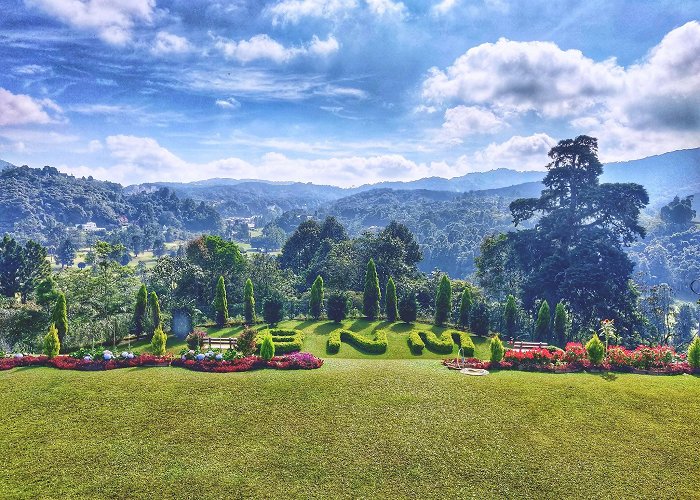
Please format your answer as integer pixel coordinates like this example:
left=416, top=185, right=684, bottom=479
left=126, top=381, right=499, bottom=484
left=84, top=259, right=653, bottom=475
left=0, top=362, right=700, bottom=498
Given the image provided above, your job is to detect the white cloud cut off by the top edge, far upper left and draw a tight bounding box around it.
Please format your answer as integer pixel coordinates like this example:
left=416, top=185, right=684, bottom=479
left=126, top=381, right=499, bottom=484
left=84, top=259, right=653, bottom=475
left=25, top=0, right=156, bottom=45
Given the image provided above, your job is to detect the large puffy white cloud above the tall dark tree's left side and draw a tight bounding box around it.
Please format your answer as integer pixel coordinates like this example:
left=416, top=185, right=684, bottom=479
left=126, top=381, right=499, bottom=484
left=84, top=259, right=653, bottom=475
left=423, top=38, right=624, bottom=117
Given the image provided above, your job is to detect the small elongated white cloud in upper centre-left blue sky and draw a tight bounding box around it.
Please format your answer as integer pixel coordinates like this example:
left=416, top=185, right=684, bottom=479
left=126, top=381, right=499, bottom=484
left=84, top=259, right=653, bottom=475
left=215, top=34, right=340, bottom=63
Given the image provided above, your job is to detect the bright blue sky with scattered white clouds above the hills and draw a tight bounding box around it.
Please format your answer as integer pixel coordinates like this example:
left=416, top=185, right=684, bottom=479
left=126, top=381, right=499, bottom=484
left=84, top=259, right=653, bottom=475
left=0, top=0, right=700, bottom=186
